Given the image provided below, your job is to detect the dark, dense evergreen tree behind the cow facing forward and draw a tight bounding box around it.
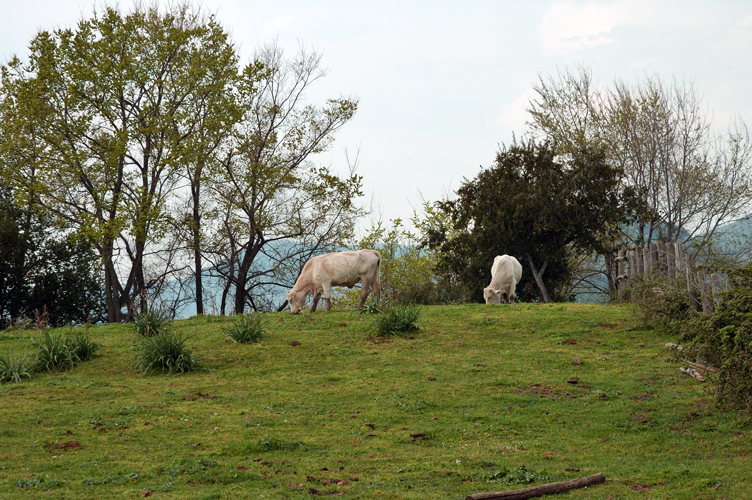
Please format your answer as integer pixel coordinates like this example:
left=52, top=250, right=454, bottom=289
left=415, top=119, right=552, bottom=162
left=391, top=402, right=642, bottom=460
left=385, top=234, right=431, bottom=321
left=427, top=140, right=636, bottom=302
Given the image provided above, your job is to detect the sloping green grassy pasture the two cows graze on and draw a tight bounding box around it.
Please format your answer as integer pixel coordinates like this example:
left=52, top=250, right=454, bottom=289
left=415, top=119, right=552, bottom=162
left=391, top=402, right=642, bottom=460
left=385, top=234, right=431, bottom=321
left=0, top=304, right=752, bottom=499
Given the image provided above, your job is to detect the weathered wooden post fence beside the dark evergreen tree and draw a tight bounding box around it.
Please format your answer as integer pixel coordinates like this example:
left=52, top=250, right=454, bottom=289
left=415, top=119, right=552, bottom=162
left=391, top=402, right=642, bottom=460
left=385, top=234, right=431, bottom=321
left=615, top=241, right=728, bottom=313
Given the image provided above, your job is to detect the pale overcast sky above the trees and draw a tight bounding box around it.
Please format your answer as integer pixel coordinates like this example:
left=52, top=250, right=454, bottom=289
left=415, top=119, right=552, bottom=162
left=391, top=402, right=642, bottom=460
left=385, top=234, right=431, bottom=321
left=0, top=0, right=752, bottom=229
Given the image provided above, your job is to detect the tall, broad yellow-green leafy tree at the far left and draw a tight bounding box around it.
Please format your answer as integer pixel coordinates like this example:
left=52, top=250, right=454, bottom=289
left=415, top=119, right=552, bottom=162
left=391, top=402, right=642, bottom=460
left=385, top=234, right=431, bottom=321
left=0, top=5, right=237, bottom=321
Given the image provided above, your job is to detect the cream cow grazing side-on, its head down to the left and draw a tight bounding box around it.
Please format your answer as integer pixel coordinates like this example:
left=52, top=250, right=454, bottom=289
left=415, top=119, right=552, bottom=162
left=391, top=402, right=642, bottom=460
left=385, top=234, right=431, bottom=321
left=287, top=250, right=381, bottom=314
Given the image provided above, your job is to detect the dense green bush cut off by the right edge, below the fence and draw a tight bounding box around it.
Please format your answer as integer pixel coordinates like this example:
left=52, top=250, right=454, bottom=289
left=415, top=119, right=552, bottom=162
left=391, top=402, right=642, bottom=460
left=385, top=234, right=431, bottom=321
left=681, top=264, right=752, bottom=412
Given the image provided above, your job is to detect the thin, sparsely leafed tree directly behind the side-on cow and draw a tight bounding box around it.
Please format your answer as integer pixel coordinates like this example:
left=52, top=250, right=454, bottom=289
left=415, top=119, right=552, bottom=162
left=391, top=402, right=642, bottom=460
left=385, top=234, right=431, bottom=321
left=207, top=43, right=362, bottom=313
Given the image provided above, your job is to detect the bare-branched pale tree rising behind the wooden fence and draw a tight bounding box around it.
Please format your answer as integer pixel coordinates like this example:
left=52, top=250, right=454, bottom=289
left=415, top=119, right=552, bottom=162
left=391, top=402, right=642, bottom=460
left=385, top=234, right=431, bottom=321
left=528, top=67, right=752, bottom=252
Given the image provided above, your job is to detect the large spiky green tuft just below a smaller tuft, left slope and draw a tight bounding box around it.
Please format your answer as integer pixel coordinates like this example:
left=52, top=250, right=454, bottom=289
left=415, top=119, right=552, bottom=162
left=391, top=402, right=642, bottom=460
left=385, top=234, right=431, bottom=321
left=134, top=330, right=197, bottom=374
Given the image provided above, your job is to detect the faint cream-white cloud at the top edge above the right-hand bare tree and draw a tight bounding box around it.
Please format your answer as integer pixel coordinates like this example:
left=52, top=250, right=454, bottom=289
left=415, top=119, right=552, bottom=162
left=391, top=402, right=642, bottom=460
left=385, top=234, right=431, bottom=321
left=539, top=0, right=652, bottom=56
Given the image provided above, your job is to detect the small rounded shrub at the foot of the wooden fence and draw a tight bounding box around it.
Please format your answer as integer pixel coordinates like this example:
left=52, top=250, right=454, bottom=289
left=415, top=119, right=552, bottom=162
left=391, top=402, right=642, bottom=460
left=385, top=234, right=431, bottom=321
left=628, top=276, right=697, bottom=333
